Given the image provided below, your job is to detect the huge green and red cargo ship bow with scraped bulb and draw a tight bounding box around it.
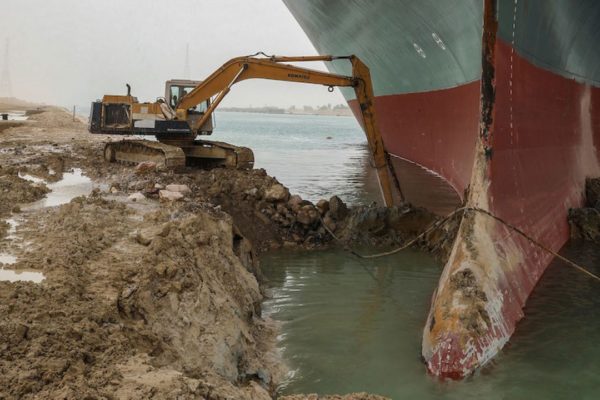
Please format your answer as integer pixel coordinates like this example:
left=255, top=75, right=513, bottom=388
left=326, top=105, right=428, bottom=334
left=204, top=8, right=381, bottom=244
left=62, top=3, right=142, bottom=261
left=283, top=0, right=600, bottom=379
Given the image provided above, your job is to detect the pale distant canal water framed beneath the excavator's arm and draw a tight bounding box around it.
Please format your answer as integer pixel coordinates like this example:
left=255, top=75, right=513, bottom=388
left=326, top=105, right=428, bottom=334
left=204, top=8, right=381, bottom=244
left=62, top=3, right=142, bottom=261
left=210, top=112, right=379, bottom=204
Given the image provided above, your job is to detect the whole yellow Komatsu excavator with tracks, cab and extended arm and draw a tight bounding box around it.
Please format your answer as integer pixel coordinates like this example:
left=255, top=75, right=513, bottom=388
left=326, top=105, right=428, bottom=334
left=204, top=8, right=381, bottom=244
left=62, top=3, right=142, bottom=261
left=89, top=53, right=393, bottom=206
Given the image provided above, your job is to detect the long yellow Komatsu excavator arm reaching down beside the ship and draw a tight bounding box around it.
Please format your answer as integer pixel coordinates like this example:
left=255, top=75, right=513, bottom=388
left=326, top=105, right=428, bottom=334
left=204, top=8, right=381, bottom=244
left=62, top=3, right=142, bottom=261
left=176, top=56, right=394, bottom=206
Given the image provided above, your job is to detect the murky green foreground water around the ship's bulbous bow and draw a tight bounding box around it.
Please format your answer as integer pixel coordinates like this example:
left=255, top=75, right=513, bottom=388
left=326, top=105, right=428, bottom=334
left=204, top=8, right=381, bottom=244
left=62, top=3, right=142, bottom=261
left=261, top=244, right=600, bottom=399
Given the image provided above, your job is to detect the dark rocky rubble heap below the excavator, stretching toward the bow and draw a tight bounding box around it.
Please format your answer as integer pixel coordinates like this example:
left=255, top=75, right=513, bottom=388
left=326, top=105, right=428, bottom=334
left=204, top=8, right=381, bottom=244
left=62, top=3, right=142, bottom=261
left=100, top=166, right=456, bottom=254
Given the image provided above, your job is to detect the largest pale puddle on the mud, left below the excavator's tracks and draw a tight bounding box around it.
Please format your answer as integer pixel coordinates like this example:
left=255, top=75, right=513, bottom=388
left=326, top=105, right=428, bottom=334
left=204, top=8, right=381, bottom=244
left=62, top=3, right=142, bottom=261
left=19, top=168, right=94, bottom=211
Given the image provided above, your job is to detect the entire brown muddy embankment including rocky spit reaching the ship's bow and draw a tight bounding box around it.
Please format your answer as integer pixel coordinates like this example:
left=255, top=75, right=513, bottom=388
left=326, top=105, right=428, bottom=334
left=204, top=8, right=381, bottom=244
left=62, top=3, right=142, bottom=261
left=0, top=104, right=447, bottom=399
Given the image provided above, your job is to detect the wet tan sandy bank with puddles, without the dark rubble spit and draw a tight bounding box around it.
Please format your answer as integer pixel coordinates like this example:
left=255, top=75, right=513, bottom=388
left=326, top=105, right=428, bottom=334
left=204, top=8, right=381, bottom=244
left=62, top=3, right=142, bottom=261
left=0, top=104, right=283, bottom=399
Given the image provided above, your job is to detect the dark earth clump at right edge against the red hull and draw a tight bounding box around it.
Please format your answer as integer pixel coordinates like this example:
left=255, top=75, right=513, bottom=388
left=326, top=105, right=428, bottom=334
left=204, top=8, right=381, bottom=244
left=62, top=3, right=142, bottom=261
left=567, top=178, right=600, bottom=242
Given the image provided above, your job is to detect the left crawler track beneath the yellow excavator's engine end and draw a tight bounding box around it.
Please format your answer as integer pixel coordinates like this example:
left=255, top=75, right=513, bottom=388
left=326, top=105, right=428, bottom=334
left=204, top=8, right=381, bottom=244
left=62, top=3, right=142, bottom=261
left=104, top=140, right=185, bottom=168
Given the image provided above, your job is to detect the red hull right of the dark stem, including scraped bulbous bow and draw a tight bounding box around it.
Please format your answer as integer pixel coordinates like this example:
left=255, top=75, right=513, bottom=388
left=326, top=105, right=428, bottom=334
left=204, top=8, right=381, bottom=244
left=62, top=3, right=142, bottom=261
left=423, top=9, right=600, bottom=378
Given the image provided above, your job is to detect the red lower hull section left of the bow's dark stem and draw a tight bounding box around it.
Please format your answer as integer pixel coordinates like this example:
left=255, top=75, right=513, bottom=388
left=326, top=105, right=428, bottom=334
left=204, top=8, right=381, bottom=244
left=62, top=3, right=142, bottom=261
left=349, top=81, right=480, bottom=215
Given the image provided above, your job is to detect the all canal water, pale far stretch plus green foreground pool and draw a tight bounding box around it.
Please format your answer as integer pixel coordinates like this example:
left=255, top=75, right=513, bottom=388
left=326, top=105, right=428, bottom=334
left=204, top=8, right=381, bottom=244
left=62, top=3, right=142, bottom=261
left=214, top=112, right=600, bottom=400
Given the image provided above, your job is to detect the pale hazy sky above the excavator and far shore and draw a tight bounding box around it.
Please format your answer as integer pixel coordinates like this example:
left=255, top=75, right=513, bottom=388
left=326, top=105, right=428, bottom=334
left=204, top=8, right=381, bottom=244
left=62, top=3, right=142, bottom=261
left=0, top=0, right=343, bottom=107
